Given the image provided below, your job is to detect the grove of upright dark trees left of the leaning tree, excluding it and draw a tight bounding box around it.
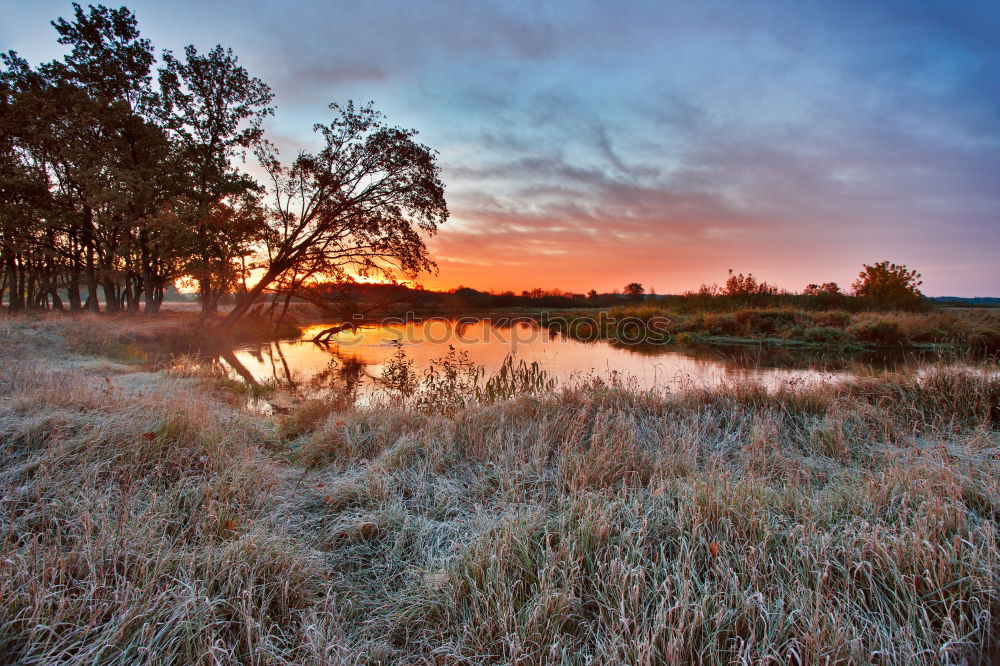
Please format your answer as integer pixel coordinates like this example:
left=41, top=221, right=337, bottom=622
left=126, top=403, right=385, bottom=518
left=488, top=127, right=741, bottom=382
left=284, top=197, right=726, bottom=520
left=0, top=4, right=272, bottom=312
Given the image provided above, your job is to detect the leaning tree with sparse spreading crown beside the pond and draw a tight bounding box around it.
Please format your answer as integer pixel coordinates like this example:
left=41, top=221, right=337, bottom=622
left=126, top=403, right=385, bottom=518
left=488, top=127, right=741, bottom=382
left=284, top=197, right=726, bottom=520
left=222, top=103, right=448, bottom=327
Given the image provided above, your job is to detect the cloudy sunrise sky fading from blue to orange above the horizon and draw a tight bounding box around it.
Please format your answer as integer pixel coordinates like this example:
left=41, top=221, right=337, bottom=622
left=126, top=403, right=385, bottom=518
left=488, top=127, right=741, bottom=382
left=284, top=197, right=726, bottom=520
left=0, top=0, right=1000, bottom=296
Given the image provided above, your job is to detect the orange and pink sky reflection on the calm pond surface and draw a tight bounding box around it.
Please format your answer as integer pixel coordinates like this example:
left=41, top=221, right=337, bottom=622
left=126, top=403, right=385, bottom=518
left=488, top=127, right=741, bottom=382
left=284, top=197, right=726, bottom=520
left=223, top=319, right=964, bottom=402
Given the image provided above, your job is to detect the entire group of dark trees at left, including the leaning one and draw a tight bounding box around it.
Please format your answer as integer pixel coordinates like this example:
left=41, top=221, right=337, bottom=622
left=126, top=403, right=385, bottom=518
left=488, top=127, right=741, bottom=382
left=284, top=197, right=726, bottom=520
left=0, top=4, right=448, bottom=324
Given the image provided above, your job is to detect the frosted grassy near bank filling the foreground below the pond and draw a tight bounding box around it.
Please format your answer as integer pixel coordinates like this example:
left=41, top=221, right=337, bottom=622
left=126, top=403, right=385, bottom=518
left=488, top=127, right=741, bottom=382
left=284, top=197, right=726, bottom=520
left=0, top=317, right=1000, bottom=664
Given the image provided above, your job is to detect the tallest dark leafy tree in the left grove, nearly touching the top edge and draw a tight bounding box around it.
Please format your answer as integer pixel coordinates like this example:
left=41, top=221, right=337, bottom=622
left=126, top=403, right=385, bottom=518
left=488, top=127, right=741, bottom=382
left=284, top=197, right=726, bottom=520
left=40, top=3, right=173, bottom=312
